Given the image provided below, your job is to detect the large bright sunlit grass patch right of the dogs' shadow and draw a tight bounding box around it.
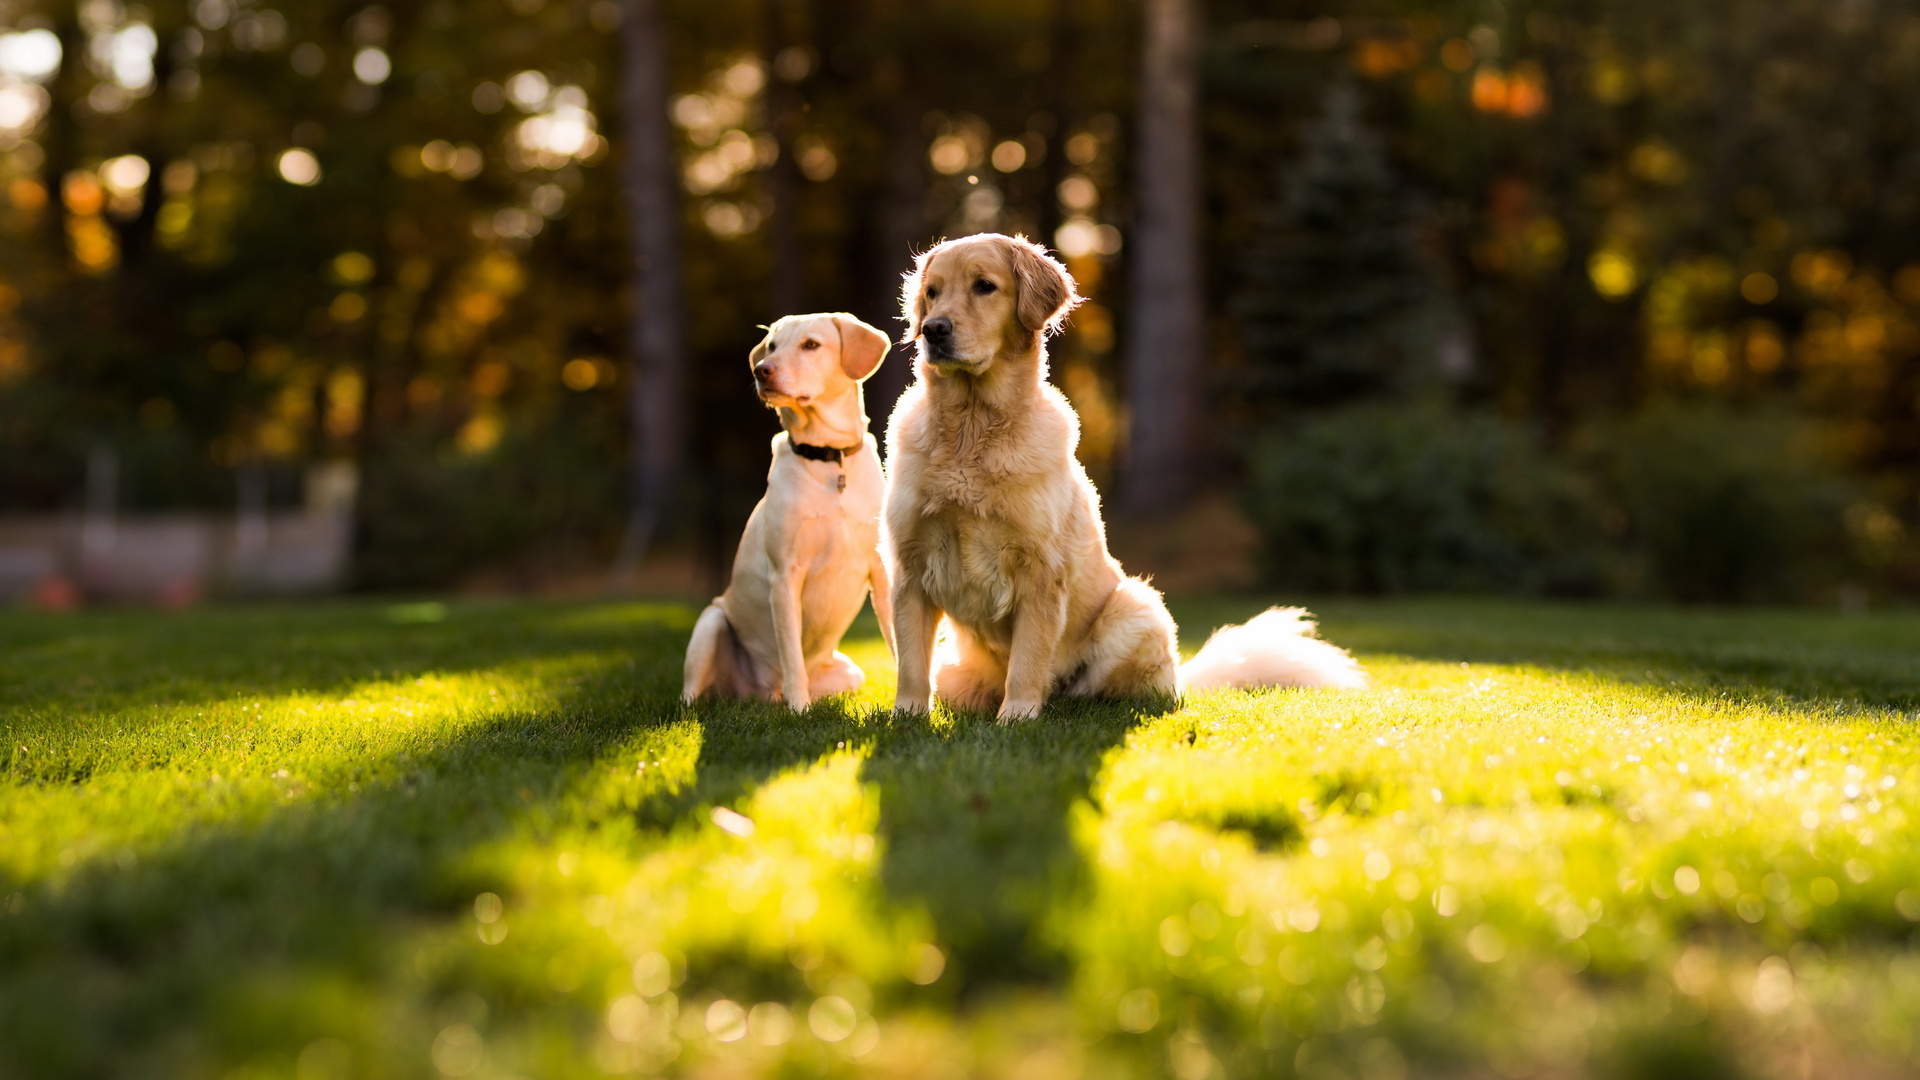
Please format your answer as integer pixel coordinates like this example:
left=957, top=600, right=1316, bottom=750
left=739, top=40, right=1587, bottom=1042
left=1069, top=645, right=1920, bottom=1074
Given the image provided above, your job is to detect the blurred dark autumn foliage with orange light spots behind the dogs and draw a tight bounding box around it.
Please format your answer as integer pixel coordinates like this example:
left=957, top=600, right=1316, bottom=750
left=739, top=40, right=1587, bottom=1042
left=0, top=0, right=1920, bottom=586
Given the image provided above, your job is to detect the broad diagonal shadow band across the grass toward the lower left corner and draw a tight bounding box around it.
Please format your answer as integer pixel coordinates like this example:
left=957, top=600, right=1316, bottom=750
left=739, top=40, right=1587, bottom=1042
left=0, top=687, right=672, bottom=1076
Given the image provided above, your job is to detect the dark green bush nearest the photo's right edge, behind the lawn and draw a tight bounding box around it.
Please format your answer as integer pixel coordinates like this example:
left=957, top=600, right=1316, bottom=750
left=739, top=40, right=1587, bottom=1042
left=1599, top=404, right=1857, bottom=601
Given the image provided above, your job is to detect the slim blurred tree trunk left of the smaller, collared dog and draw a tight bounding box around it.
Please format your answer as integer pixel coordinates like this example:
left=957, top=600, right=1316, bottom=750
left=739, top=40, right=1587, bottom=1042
left=614, top=0, right=687, bottom=586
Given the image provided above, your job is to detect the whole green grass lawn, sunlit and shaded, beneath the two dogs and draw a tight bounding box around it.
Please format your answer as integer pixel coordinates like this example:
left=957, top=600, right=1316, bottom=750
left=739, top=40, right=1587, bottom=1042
left=0, top=600, right=1920, bottom=1080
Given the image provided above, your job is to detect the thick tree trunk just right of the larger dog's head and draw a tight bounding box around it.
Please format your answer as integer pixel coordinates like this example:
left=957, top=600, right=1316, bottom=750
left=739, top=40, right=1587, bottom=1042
left=1125, top=0, right=1206, bottom=517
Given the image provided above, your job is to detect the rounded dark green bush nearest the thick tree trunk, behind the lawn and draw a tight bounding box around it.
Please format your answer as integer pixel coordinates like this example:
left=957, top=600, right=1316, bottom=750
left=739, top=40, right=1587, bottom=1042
left=1248, top=405, right=1609, bottom=594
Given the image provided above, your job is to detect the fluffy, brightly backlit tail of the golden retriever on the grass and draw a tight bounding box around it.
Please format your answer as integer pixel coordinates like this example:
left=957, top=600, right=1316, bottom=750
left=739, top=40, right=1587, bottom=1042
left=1181, top=607, right=1367, bottom=694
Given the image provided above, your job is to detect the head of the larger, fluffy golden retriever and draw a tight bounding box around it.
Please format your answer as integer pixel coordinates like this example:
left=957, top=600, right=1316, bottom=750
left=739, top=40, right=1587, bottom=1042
left=900, top=233, right=1081, bottom=375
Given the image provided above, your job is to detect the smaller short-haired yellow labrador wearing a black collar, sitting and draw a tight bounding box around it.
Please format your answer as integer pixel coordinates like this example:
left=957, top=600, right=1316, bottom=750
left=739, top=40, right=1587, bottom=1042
left=682, top=313, right=893, bottom=711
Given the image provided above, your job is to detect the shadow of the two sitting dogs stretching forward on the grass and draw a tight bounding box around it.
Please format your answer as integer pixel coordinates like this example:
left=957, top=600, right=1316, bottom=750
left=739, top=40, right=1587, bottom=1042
left=639, top=684, right=1173, bottom=994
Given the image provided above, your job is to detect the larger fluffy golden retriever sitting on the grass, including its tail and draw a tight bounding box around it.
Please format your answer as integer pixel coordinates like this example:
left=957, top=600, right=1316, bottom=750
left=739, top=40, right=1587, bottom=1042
left=881, top=234, right=1365, bottom=721
